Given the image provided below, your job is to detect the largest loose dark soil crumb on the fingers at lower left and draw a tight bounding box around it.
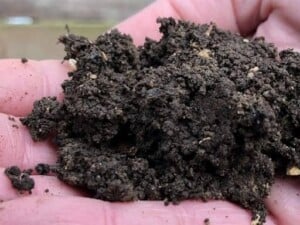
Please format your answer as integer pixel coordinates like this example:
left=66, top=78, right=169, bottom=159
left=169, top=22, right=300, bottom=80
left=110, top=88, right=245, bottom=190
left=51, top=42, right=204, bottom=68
left=5, top=166, right=34, bottom=193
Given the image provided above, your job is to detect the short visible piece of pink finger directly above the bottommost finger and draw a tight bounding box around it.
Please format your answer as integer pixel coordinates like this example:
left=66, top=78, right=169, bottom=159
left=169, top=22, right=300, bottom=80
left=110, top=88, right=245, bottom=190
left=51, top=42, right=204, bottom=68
left=0, top=168, right=82, bottom=201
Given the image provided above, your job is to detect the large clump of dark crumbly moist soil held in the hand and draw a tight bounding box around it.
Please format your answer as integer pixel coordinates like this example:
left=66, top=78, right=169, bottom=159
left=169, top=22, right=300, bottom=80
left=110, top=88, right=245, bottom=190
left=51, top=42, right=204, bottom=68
left=17, top=18, right=300, bottom=224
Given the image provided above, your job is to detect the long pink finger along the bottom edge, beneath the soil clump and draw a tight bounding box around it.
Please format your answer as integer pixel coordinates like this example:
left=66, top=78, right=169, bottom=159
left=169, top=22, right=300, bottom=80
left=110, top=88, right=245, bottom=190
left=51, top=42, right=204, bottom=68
left=0, top=196, right=274, bottom=225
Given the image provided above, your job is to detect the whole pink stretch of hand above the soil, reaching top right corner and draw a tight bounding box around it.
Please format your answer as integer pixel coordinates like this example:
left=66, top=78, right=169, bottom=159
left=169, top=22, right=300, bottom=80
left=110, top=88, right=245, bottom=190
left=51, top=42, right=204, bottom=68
left=118, top=0, right=300, bottom=51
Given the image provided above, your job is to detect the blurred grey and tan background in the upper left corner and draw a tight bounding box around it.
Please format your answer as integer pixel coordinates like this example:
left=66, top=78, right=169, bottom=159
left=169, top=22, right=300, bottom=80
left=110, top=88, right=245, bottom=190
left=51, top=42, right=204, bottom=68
left=0, top=0, right=152, bottom=59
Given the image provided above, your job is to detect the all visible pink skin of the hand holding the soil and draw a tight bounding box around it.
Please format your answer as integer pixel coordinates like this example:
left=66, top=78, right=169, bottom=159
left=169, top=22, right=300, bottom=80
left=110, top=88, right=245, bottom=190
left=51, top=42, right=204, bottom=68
left=0, top=0, right=300, bottom=225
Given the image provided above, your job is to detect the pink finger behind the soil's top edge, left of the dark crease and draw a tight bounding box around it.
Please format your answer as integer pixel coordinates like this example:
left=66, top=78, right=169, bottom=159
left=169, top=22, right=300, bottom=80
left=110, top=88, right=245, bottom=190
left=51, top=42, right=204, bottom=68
left=117, top=0, right=261, bottom=45
